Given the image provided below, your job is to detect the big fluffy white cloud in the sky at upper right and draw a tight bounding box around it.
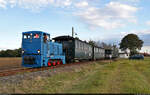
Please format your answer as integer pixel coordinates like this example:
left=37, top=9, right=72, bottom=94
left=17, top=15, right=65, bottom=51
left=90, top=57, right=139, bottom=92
left=76, top=2, right=138, bottom=29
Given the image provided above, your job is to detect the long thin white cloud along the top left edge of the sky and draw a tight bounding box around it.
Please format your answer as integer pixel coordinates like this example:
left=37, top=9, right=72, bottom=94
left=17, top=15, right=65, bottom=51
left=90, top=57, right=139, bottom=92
left=0, top=0, right=72, bottom=10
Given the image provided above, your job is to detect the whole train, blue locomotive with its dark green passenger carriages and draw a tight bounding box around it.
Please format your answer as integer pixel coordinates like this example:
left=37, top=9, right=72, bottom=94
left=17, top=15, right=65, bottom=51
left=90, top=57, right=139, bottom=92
left=22, top=31, right=118, bottom=68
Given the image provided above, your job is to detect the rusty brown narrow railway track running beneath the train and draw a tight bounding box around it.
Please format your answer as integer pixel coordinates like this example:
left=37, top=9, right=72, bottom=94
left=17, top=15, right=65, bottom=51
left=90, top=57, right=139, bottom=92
left=0, top=60, right=115, bottom=77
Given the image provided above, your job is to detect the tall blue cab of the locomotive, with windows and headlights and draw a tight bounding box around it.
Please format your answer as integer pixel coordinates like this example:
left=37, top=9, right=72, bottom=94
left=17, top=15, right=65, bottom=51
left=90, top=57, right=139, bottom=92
left=22, top=31, right=50, bottom=67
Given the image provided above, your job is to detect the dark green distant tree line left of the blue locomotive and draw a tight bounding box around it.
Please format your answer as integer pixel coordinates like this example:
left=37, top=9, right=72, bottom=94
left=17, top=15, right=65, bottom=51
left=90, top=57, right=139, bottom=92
left=0, top=48, right=21, bottom=57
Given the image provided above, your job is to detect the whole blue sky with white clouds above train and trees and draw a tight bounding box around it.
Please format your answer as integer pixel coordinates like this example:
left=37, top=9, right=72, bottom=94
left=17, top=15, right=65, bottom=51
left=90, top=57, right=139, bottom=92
left=0, top=0, right=150, bottom=49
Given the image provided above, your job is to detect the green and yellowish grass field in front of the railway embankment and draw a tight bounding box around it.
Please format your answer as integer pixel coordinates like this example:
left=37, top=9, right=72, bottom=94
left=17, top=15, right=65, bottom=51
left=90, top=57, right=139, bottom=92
left=0, top=58, right=150, bottom=93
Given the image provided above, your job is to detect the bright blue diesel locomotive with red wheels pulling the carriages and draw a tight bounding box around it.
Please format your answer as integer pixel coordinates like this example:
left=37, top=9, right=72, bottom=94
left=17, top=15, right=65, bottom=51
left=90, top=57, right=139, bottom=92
left=22, top=31, right=65, bottom=68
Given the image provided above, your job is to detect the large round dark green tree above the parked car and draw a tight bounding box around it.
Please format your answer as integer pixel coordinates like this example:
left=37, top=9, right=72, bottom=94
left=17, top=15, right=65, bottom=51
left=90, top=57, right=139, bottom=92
left=120, top=34, right=144, bottom=55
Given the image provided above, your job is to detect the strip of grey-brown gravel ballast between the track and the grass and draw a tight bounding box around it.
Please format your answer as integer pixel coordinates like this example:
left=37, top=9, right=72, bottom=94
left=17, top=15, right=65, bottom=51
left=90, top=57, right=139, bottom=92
left=0, top=62, right=91, bottom=85
